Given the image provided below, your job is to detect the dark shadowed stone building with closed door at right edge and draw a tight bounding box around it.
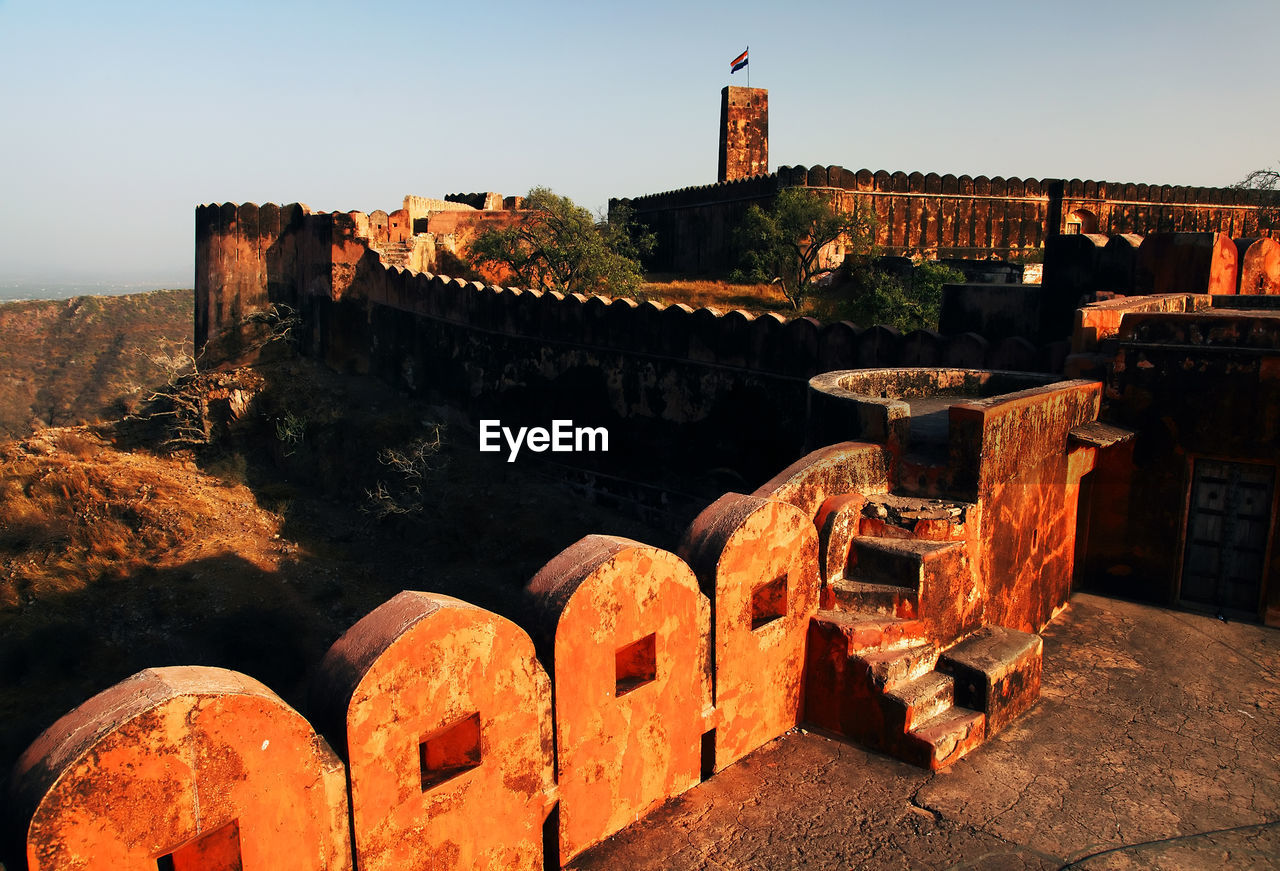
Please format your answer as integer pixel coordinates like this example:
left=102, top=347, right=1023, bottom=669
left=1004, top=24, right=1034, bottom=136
left=1070, top=295, right=1280, bottom=625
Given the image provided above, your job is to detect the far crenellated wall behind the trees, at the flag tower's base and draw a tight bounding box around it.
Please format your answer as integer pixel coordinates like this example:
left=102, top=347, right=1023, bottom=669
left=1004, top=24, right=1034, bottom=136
left=614, top=167, right=1280, bottom=274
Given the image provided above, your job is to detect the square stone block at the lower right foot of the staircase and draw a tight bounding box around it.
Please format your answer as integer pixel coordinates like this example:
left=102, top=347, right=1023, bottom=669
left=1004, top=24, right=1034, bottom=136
left=938, top=626, right=1044, bottom=737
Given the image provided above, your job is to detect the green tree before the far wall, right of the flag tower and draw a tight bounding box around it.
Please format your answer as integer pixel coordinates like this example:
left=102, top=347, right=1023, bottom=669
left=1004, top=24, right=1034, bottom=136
left=735, top=187, right=876, bottom=309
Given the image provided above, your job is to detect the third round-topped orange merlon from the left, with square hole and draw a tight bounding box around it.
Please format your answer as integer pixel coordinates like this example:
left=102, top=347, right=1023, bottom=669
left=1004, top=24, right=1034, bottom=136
left=529, top=535, right=710, bottom=862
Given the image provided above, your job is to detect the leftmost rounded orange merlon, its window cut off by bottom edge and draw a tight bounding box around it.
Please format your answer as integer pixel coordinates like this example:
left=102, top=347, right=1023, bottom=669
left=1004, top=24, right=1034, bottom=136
left=13, top=666, right=351, bottom=871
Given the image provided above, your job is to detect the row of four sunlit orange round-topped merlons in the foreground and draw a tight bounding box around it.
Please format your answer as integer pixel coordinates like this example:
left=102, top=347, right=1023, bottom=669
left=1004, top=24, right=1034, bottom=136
left=10, top=458, right=844, bottom=871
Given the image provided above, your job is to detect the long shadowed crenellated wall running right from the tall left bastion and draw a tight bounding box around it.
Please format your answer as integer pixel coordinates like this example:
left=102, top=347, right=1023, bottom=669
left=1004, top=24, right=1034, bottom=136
left=196, top=198, right=1066, bottom=496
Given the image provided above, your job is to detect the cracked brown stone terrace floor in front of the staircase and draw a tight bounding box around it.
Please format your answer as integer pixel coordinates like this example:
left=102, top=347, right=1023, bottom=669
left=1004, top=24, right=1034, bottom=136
left=571, top=594, right=1280, bottom=871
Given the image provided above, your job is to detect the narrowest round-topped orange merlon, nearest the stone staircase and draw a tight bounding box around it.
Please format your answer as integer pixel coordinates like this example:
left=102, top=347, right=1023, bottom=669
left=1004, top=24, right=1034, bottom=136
left=678, top=493, right=818, bottom=771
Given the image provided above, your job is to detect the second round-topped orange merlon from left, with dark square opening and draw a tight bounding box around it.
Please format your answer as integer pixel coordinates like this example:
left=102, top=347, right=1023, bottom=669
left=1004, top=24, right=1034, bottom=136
left=314, top=590, right=553, bottom=871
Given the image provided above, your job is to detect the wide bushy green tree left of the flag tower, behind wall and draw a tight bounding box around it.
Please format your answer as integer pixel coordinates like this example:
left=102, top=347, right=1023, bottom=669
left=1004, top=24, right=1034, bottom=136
left=470, top=187, right=653, bottom=296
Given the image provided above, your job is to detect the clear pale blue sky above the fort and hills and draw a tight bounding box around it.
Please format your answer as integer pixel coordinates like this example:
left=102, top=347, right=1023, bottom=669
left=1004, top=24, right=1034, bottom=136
left=0, top=0, right=1280, bottom=287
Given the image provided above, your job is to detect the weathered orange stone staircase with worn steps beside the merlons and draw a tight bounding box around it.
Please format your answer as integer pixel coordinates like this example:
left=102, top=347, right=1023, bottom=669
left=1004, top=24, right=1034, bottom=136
left=805, top=494, right=1042, bottom=770
